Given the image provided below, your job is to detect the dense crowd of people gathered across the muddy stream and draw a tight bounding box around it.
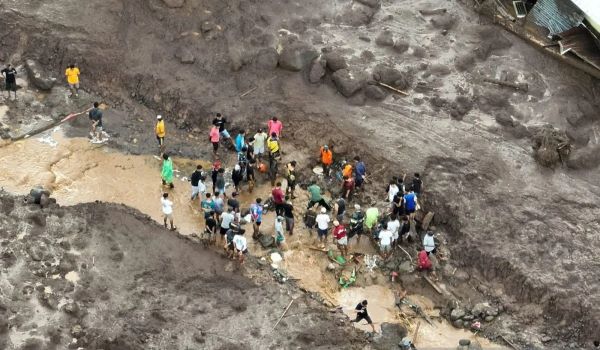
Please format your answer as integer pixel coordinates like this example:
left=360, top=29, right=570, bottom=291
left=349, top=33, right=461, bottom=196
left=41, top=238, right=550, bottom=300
left=155, top=109, right=436, bottom=269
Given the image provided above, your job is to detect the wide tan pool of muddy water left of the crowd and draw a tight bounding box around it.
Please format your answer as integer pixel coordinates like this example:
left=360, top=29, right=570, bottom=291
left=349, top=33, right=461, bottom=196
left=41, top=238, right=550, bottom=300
left=0, top=129, right=206, bottom=234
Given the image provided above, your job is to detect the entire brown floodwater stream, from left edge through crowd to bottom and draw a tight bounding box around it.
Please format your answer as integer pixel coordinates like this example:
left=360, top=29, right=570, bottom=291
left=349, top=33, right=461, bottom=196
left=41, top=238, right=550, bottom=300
left=0, top=130, right=504, bottom=349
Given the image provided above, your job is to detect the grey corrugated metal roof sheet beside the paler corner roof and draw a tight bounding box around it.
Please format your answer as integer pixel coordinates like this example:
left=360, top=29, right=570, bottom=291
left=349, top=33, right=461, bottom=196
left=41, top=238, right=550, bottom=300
left=528, top=0, right=585, bottom=36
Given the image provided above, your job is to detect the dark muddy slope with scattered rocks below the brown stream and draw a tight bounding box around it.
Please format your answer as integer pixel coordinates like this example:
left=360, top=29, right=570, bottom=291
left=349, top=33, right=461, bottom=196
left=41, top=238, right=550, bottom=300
left=0, top=193, right=364, bottom=350
